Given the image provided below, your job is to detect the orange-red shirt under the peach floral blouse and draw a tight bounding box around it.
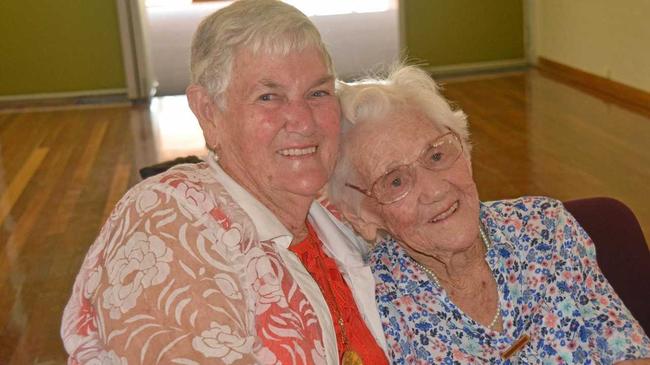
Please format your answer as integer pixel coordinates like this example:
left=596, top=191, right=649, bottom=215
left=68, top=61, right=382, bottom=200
left=289, top=223, right=388, bottom=365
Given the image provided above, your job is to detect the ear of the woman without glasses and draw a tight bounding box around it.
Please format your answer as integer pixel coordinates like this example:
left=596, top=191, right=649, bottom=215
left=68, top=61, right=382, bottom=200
left=185, top=84, right=221, bottom=150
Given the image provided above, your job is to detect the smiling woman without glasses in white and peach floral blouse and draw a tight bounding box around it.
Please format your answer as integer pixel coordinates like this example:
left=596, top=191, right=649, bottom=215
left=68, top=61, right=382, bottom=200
left=61, top=0, right=386, bottom=365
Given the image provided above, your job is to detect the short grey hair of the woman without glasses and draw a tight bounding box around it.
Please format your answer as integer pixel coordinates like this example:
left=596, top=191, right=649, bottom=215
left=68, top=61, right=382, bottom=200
left=190, top=0, right=334, bottom=109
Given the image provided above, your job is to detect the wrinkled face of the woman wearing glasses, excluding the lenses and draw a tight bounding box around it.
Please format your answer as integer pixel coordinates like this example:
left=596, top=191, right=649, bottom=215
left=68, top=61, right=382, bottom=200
left=346, top=109, right=479, bottom=257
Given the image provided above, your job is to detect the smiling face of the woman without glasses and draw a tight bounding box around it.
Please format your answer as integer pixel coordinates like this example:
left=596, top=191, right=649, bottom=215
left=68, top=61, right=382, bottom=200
left=216, top=48, right=340, bottom=201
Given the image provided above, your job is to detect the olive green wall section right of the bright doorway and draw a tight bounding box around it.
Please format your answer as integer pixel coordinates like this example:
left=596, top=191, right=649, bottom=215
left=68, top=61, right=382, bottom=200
left=401, top=0, right=525, bottom=66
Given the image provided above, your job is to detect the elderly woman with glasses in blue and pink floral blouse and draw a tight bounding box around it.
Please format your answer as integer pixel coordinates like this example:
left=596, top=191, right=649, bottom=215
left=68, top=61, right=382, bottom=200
left=329, top=66, right=650, bottom=364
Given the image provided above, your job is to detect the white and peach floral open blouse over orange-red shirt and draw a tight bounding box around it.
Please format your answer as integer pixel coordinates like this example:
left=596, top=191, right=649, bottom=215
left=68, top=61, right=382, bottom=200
left=61, top=154, right=385, bottom=365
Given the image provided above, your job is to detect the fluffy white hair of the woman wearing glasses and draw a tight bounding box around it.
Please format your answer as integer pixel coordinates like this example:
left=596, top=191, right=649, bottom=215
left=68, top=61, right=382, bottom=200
left=328, top=64, right=471, bottom=215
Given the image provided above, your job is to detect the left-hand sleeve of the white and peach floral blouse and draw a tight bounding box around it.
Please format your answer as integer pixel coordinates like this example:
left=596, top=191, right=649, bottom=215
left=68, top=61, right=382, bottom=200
left=62, top=181, right=256, bottom=364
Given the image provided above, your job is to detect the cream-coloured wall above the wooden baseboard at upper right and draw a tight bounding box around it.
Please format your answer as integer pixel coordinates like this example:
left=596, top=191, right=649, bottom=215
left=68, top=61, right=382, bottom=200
left=530, top=0, right=650, bottom=92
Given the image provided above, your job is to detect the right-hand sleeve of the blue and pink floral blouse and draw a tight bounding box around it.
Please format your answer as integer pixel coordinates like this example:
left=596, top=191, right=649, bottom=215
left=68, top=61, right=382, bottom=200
left=558, top=207, right=650, bottom=363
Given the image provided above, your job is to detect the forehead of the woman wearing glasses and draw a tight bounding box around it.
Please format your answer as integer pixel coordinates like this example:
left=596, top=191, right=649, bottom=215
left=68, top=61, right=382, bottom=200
left=346, top=109, right=444, bottom=182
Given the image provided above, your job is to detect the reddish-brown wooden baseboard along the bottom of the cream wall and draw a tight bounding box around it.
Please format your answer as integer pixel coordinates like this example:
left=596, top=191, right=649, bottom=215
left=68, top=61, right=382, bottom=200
left=537, top=57, right=650, bottom=112
